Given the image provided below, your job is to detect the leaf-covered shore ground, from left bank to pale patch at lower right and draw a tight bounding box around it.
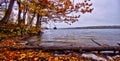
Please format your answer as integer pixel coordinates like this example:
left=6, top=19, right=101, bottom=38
left=0, top=38, right=120, bottom=61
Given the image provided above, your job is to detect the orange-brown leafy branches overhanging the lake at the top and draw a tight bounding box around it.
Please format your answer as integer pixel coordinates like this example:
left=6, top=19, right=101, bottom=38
left=20, top=0, right=93, bottom=23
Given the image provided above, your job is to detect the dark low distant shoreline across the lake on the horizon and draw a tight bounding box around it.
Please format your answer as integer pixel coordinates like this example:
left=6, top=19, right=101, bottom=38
left=58, top=26, right=120, bottom=29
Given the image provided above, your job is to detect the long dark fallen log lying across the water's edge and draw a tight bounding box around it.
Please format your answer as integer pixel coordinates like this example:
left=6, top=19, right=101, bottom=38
left=0, top=46, right=120, bottom=51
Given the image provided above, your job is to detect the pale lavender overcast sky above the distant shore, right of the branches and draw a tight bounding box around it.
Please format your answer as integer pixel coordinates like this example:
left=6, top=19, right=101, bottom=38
left=49, top=0, right=120, bottom=27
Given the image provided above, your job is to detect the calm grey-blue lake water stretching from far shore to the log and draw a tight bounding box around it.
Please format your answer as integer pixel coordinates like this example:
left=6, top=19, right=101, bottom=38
left=23, top=29, right=120, bottom=48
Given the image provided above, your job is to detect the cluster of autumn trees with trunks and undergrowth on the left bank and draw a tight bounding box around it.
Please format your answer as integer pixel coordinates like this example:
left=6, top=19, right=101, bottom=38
left=0, top=0, right=93, bottom=39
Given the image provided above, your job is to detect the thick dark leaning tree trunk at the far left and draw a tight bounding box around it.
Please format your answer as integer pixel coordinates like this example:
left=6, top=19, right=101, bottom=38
left=1, top=0, right=15, bottom=23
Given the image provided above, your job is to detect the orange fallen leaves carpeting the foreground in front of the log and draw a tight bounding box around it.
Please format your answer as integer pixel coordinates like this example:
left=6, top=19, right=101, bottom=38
left=0, top=48, right=120, bottom=61
